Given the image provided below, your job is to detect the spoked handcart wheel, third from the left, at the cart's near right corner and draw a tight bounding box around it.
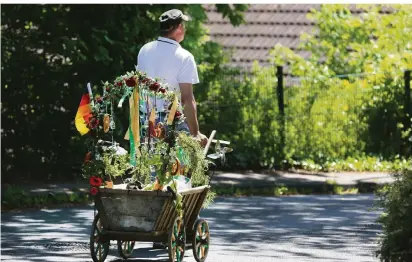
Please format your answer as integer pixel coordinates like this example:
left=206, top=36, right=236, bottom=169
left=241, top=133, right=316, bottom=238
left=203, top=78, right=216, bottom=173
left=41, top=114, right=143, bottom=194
left=168, top=217, right=186, bottom=262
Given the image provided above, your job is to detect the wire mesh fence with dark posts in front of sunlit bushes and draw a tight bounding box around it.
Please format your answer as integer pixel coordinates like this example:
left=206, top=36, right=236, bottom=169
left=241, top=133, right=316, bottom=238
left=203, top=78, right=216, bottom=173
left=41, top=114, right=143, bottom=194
left=198, top=67, right=412, bottom=162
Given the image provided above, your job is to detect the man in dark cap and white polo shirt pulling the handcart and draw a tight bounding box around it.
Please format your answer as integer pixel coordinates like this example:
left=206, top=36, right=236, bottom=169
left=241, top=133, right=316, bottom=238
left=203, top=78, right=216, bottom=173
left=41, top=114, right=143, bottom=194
left=137, top=9, right=207, bottom=146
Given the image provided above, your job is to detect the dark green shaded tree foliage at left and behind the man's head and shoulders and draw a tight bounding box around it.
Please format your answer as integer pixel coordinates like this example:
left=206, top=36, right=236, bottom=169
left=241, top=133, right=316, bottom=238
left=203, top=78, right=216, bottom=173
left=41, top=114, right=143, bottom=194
left=1, top=4, right=247, bottom=181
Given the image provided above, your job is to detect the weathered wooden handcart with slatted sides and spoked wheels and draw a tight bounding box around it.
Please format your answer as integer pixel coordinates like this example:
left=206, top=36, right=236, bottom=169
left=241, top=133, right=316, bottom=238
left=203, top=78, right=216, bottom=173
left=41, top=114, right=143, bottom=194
left=90, top=186, right=210, bottom=262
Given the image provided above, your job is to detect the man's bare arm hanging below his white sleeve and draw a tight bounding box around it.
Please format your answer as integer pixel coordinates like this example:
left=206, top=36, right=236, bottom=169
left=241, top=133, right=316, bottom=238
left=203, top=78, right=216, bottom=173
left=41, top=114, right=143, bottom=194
left=179, top=83, right=199, bottom=137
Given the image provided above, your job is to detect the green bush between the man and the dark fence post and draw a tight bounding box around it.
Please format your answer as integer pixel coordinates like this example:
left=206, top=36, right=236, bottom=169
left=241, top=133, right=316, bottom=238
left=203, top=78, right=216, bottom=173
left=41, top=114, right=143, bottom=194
left=198, top=64, right=282, bottom=168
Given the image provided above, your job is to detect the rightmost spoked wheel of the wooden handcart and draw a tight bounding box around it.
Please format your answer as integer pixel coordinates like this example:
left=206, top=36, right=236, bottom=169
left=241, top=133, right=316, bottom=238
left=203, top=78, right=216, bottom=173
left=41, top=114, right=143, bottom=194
left=192, top=219, right=210, bottom=262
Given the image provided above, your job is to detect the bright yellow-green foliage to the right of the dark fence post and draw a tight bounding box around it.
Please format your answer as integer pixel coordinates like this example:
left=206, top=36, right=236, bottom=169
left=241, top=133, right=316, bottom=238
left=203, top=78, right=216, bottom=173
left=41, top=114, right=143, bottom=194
left=272, top=5, right=412, bottom=164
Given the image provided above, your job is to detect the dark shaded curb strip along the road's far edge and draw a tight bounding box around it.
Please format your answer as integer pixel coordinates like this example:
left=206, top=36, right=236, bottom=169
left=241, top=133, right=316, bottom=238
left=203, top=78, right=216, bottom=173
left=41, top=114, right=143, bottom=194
left=1, top=182, right=387, bottom=212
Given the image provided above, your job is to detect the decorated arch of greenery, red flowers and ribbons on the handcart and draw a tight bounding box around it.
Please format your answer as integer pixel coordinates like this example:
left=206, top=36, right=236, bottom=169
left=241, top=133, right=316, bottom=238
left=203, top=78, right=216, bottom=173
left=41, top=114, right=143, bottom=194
left=77, top=71, right=214, bottom=216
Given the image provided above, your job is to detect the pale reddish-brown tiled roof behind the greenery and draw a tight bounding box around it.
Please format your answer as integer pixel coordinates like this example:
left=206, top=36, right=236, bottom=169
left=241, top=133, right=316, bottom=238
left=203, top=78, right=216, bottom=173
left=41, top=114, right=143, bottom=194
left=205, top=4, right=320, bottom=66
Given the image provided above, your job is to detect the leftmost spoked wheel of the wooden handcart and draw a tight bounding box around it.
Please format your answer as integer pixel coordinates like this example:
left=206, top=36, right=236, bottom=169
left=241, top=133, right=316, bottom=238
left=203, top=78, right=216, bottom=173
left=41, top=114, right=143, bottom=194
left=90, top=213, right=110, bottom=262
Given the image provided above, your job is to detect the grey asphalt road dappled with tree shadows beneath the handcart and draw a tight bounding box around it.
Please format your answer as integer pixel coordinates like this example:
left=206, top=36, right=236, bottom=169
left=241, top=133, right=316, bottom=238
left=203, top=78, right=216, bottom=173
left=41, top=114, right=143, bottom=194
left=1, top=195, right=381, bottom=262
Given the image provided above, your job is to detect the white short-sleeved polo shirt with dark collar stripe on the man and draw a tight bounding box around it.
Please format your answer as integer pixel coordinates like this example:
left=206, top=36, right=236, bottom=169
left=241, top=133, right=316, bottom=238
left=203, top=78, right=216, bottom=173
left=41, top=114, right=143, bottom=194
left=137, top=37, right=199, bottom=111
